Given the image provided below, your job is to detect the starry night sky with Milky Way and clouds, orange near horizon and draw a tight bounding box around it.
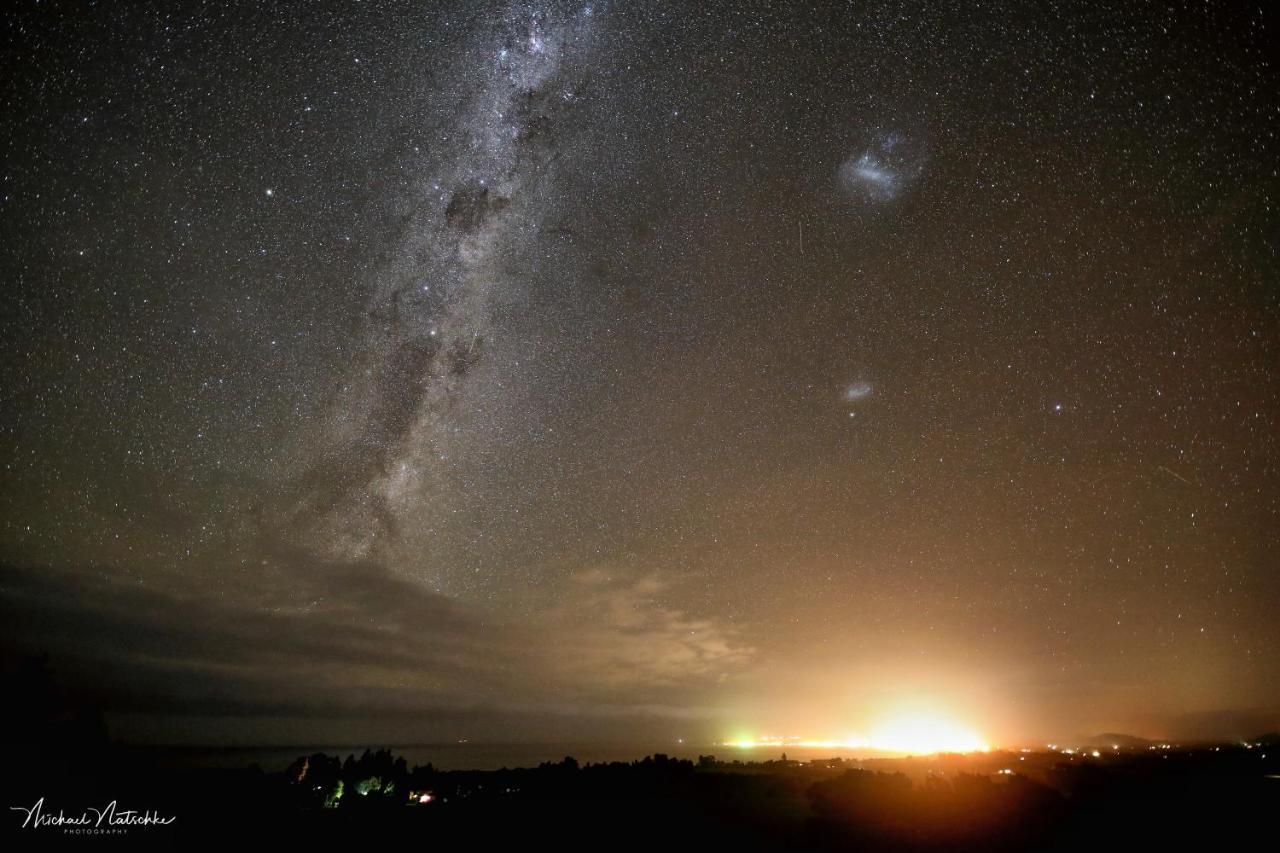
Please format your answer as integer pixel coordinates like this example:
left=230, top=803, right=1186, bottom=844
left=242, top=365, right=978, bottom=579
left=0, top=0, right=1280, bottom=743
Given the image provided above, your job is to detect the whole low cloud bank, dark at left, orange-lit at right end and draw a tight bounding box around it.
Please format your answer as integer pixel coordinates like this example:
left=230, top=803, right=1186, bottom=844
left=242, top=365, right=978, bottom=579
left=0, top=555, right=750, bottom=739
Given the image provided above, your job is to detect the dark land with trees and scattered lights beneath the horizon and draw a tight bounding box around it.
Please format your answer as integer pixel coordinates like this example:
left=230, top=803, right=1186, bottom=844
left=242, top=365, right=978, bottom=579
left=5, top=743, right=1280, bottom=850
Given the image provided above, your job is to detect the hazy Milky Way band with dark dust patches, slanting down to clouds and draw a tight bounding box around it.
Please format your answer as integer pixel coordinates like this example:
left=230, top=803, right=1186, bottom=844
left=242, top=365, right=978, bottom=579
left=277, top=6, right=596, bottom=566
